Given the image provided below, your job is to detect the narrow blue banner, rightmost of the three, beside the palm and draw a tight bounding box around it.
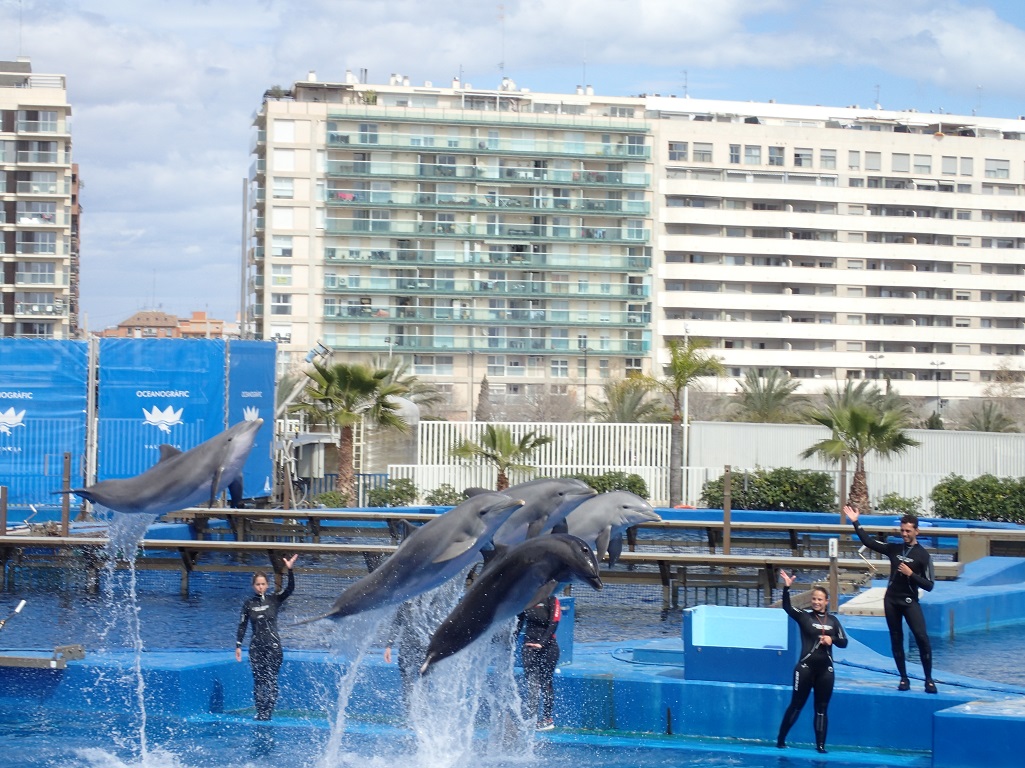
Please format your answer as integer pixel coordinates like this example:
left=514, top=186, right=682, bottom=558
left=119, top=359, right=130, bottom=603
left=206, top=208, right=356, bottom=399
left=228, top=339, right=277, bottom=498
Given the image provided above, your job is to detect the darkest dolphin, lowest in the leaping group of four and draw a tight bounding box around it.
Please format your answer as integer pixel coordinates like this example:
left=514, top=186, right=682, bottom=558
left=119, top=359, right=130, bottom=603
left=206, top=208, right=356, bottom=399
left=420, top=533, right=602, bottom=675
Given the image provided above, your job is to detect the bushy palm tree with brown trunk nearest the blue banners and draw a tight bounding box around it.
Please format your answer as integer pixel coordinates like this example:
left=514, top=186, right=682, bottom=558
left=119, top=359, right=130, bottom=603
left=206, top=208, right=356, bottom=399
left=291, top=360, right=409, bottom=502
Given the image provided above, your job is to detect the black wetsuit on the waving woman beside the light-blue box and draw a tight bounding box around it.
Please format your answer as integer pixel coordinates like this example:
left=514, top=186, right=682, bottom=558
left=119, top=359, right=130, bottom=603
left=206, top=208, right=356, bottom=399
left=776, top=587, right=847, bottom=752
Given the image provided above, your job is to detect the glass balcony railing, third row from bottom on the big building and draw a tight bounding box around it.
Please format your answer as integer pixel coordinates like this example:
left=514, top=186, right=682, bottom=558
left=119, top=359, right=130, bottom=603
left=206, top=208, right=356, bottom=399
left=324, top=275, right=649, bottom=300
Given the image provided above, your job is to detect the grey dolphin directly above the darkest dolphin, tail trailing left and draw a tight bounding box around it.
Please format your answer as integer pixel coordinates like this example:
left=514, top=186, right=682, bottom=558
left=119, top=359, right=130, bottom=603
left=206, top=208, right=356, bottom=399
left=299, top=493, right=523, bottom=623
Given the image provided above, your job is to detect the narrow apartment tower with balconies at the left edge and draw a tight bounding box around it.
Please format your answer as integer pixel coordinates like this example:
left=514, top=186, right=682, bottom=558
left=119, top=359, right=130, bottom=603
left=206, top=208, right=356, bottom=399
left=0, top=58, right=79, bottom=338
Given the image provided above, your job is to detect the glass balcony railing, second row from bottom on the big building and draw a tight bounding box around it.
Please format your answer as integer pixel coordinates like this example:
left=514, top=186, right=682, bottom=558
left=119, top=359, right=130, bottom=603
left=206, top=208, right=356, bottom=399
left=324, top=305, right=651, bottom=327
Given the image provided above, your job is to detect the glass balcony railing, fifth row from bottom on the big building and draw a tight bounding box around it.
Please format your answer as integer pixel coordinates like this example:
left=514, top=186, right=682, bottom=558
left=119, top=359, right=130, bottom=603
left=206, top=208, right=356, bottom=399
left=325, top=217, right=650, bottom=243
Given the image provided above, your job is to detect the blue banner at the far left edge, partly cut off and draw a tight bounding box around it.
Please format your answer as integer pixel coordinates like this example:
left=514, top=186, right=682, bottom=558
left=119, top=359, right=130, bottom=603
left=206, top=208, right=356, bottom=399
left=0, top=338, right=88, bottom=506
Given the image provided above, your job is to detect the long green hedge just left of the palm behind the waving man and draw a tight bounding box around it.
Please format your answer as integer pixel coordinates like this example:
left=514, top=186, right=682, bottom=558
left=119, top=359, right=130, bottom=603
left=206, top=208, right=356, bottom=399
left=701, top=467, right=836, bottom=512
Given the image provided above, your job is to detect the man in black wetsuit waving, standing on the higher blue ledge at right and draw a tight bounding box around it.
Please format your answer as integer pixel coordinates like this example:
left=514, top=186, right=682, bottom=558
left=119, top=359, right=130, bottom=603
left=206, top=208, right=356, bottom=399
left=844, top=507, right=936, bottom=693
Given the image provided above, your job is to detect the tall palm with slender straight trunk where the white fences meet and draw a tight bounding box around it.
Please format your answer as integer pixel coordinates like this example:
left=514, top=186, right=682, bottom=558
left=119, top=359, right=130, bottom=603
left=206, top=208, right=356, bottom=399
left=643, top=337, right=726, bottom=507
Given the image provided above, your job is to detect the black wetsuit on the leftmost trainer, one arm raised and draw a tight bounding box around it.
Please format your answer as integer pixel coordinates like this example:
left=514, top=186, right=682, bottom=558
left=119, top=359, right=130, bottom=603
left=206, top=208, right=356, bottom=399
left=235, top=569, right=295, bottom=720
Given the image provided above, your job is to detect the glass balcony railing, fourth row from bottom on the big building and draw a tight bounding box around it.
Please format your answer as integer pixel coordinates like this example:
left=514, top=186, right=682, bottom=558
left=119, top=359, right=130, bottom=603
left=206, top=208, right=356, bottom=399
left=324, top=247, right=651, bottom=272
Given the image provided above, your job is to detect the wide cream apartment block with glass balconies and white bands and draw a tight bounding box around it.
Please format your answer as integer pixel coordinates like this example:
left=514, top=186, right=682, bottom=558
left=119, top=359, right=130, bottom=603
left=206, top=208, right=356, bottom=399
left=247, top=73, right=1025, bottom=417
